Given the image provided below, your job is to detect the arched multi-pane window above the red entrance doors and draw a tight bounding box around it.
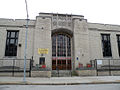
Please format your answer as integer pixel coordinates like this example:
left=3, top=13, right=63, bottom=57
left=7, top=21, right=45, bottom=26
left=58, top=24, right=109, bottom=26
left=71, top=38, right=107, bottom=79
left=52, top=34, right=71, bottom=57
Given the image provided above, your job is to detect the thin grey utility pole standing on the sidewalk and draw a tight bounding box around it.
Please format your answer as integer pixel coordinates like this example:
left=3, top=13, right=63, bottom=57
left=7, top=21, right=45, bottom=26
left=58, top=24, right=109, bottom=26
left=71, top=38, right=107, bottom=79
left=23, top=0, right=29, bottom=82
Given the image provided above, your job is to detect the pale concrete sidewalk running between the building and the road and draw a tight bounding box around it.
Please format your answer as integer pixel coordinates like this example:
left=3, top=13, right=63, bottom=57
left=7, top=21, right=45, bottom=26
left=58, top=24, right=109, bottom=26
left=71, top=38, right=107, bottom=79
left=0, top=76, right=120, bottom=85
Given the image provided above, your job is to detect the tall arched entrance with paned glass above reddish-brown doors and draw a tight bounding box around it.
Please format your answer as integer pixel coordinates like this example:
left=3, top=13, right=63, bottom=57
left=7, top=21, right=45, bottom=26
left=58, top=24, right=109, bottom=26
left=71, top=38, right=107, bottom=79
left=52, top=33, right=72, bottom=70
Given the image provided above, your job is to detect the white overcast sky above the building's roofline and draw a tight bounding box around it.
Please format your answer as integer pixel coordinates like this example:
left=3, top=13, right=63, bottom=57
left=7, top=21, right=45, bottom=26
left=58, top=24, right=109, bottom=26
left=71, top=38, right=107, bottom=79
left=0, top=0, right=120, bottom=25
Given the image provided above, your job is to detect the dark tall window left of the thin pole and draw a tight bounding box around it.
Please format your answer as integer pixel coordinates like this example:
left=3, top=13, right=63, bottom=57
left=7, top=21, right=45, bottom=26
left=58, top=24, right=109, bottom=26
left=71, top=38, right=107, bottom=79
left=5, top=31, right=18, bottom=56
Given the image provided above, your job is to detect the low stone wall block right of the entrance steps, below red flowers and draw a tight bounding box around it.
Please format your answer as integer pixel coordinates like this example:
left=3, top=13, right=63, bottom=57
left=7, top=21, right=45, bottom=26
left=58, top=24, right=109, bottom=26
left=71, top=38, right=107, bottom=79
left=76, top=70, right=96, bottom=76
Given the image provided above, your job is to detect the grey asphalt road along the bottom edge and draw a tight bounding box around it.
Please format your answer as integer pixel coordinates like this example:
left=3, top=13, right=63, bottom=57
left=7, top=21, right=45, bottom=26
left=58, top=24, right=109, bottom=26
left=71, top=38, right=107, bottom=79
left=0, top=84, right=120, bottom=90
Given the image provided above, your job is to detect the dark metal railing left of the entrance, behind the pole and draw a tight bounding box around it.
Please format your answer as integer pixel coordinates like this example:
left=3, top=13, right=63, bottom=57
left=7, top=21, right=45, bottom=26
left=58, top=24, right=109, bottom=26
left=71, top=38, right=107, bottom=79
left=0, top=59, right=33, bottom=77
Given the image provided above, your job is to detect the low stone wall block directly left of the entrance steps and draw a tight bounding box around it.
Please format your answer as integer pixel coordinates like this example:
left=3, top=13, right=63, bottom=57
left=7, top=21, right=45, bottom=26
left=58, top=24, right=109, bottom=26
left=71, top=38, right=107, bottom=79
left=31, top=71, right=51, bottom=77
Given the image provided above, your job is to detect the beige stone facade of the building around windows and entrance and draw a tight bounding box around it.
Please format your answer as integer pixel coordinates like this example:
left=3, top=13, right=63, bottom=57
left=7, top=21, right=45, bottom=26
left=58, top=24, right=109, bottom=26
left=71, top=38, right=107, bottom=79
left=0, top=13, right=120, bottom=70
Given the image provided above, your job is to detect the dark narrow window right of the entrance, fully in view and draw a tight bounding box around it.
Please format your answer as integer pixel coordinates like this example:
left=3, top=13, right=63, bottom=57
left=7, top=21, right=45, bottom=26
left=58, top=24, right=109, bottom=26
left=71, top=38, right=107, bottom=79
left=101, top=34, right=112, bottom=57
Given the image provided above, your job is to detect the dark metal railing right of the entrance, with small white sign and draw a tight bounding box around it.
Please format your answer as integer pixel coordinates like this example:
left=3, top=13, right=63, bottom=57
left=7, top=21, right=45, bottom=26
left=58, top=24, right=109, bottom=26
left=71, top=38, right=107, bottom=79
left=91, top=59, right=120, bottom=75
